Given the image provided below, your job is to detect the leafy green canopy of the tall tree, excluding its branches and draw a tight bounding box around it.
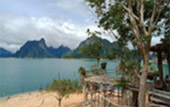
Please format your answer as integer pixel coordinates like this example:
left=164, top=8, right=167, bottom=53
left=85, top=0, right=170, bottom=46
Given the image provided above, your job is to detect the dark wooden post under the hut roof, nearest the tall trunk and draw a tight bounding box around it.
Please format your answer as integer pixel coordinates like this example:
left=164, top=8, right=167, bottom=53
left=158, top=51, right=163, bottom=88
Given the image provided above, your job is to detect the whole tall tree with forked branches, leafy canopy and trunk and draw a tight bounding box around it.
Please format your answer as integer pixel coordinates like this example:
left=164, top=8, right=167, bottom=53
left=85, top=0, right=170, bottom=107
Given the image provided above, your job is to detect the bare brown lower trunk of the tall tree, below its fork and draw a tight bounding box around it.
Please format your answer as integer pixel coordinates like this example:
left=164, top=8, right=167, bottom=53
left=138, top=52, right=149, bottom=107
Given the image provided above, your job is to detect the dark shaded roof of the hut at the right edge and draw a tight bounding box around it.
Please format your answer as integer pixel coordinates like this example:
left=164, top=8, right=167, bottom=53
left=150, top=42, right=170, bottom=52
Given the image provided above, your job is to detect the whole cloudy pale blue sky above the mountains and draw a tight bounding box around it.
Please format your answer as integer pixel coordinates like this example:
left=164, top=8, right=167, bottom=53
left=0, top=0, right=162, bottom=52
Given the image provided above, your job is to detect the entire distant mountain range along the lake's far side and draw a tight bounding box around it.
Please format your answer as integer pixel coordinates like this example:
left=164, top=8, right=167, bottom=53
left=0, top=36, right=122, bottom=58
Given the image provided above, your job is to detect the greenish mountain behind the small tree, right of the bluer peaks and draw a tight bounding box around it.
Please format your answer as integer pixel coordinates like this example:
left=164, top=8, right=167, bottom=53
left=63, top=36, right=119, bottom=58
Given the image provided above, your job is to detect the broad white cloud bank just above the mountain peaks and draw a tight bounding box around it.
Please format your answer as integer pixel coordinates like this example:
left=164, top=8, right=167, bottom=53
left=0, top=15, right=98, bottom=52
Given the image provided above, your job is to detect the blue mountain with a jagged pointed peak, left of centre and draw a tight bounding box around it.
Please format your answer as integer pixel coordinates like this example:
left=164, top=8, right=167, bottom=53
left=14, top=38, right=70, bottom=58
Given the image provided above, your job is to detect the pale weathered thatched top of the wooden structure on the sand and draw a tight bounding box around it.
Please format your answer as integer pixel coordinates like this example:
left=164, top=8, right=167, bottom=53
left=84, top=75, right=115, bottom=86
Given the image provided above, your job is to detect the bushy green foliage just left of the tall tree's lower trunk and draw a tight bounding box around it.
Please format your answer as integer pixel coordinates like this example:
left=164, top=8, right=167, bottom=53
left=117, top=50, right=141, bottom=87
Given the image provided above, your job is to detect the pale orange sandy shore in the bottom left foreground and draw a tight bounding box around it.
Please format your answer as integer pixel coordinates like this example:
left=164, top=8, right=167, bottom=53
left=0, top=91, right=83, bottom=107
